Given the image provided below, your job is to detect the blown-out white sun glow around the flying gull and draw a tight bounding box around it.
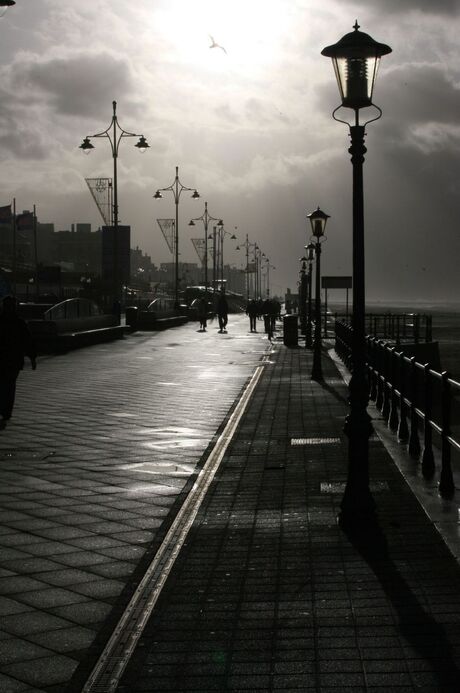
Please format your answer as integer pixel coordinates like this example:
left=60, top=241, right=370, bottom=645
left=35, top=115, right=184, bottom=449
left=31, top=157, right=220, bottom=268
left=155, top=0, right=286, bottom=76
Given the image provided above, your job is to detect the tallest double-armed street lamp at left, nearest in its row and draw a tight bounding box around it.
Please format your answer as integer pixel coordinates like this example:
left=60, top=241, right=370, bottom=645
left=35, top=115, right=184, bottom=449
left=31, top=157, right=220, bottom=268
left=79, top=101, right=149, bottom=306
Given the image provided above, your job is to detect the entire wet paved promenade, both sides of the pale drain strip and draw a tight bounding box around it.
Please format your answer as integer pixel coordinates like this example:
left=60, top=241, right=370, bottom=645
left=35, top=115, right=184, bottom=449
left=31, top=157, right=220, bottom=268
left=0, top=318, right=460, bottom=693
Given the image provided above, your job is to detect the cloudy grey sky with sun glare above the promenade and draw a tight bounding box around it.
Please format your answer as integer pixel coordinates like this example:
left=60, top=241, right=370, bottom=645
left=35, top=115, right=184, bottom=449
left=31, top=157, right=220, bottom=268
left=0, top=0, right=460, bottom=304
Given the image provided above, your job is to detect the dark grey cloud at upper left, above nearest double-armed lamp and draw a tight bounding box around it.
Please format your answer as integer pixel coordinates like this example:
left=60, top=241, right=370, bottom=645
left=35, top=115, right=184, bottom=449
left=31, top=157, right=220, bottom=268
left=15, top=53, right=132, bottom=116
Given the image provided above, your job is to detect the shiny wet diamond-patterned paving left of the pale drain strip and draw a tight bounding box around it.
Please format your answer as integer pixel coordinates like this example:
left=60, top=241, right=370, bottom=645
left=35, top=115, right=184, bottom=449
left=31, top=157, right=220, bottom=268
left=0, top=317, right=268, bottom=693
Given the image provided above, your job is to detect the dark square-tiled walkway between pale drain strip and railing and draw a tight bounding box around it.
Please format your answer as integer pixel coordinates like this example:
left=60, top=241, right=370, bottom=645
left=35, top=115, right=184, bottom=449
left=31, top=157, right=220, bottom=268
left=118, top=345, right=460, bottom=693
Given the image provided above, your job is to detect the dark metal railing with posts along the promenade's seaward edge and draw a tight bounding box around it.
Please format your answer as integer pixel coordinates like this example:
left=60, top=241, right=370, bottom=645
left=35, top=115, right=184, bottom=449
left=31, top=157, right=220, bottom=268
left=335, top=321, right=460, bottom=498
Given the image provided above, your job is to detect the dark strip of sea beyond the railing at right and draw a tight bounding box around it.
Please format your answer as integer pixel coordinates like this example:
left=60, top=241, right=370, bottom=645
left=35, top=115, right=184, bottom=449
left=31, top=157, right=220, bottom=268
left=329, top=301, right=460, bottom=382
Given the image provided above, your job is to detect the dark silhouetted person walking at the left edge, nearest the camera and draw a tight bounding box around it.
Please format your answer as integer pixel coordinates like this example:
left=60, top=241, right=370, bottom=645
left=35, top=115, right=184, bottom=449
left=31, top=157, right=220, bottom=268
left=0, top=296, right=37, bottom=421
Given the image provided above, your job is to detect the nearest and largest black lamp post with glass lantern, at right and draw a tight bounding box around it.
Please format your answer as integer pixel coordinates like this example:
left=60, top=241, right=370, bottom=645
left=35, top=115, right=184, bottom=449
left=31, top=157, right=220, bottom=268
left=321, top=22, right=391, bottom=533
